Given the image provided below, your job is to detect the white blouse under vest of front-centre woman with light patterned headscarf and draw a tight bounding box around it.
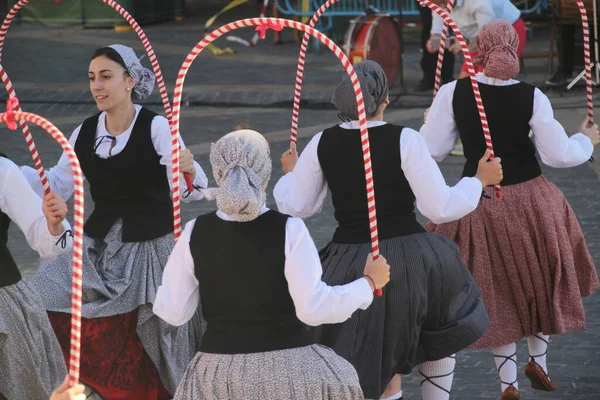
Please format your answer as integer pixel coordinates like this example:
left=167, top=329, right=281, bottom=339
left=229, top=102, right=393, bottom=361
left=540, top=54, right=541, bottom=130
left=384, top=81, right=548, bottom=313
left=153, top=206, right=373, bottom=326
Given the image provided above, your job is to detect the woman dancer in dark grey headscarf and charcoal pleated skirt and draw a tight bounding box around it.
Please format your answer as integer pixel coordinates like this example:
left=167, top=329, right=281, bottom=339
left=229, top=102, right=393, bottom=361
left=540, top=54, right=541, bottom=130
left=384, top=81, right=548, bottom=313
left=274, top=61, right=502, bottom=400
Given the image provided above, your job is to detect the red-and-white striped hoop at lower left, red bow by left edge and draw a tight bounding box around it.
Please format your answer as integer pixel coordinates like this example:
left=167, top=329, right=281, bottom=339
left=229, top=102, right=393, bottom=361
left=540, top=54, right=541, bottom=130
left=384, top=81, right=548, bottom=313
left=0, top=101, right=84, bottom=386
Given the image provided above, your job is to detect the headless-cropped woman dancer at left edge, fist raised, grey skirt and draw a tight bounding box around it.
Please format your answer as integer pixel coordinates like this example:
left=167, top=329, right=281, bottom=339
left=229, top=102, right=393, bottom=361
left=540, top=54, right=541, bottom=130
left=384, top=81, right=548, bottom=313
left=0, top=155, right=73, bottom=400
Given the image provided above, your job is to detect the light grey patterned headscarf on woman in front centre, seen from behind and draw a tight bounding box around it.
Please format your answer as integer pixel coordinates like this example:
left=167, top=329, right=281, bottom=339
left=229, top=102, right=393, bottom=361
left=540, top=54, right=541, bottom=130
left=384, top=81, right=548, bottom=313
left=202, top=129, right=273, bottom=222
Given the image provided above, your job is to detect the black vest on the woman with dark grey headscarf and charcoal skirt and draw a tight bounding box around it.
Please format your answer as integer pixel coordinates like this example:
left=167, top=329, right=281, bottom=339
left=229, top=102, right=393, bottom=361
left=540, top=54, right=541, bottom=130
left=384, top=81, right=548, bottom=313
left=317, top=124, right=425, bottom=243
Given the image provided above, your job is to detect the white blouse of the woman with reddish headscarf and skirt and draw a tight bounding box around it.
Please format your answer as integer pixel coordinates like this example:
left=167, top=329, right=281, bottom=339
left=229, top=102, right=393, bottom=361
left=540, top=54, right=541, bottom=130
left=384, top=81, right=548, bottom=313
left=420, top=72, right=594, bottom=168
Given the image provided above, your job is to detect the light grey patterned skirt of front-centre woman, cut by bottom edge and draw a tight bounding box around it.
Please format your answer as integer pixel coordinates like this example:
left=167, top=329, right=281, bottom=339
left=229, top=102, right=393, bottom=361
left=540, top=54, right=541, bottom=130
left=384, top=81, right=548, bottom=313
left=175, top=345, right=364, bottom=400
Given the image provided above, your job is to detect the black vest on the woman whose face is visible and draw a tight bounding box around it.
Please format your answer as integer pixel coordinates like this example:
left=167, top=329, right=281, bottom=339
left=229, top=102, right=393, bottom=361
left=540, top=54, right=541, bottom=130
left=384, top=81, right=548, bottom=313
left=75, top=108, right=173, bottom=242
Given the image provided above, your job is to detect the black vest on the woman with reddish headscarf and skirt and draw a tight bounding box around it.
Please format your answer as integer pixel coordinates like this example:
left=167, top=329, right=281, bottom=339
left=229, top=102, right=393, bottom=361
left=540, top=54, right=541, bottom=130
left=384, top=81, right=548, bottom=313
left=452, top=78, right=542, bottom=186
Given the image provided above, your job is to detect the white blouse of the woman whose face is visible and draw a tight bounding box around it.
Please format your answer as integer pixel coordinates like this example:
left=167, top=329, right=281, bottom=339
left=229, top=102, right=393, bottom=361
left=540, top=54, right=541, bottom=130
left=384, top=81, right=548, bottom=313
left=22, top=104, right=208, bottom=202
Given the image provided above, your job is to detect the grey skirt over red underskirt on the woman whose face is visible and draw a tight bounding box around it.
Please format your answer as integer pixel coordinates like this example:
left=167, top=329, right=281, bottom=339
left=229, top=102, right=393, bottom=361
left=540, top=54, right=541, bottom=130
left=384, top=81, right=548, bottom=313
left=31, top=220, right=204, bottom=394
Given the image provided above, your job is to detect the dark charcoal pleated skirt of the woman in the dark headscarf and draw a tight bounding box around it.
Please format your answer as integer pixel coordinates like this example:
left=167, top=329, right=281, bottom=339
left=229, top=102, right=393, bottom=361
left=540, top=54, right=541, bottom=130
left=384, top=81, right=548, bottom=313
left=315, top=233, right=489, bottom=399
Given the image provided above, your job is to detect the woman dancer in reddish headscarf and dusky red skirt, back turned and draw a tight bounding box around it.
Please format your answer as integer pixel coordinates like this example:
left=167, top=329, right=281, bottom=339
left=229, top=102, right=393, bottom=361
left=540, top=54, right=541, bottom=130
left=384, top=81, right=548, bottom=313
left=421, top=20, right=599, bottom=400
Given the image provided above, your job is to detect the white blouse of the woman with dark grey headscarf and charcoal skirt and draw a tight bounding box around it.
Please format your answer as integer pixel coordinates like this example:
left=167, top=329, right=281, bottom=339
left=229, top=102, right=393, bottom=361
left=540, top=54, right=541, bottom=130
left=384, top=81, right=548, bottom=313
left=273, top=121, right=482, bottom=224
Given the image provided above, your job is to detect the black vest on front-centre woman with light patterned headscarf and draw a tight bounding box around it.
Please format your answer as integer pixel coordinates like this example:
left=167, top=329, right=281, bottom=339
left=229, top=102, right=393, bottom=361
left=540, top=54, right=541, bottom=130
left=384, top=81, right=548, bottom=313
left=190, top=210, right=313, bottom=354
